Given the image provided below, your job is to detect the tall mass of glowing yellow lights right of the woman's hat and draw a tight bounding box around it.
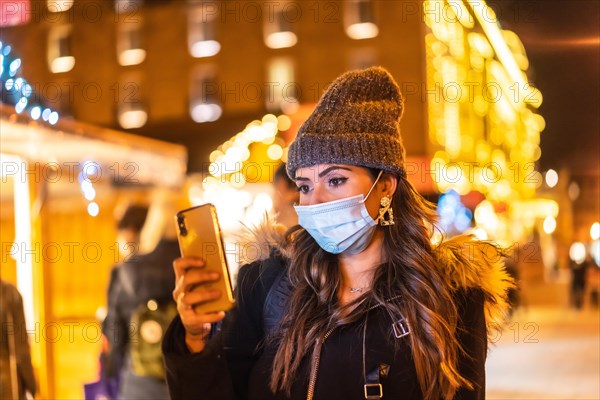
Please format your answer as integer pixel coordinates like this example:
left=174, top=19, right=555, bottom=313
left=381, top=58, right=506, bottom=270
left=423, top=1, right=558, bottom=243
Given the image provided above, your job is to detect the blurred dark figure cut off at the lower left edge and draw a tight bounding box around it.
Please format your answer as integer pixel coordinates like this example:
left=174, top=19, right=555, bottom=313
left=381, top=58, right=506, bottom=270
left=0, top=280, right=36, bottom=400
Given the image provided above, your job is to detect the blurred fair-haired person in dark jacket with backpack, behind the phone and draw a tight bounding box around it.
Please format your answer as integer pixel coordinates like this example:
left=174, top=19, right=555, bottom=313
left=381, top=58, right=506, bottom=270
left=103, top=192, right=179, bottom=400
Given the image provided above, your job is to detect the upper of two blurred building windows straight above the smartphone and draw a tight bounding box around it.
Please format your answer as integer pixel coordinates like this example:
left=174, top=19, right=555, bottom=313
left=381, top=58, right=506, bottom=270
left=188, top=2, right=221, bottom=58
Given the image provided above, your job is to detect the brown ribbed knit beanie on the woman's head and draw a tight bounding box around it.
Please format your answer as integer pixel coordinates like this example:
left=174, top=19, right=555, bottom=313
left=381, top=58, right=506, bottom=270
left=287, top=67, right=404, bottom=179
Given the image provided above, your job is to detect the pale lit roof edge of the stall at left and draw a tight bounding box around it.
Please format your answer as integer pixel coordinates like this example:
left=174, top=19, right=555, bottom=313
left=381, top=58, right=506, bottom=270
left=0, top=103, right=187, bottom=187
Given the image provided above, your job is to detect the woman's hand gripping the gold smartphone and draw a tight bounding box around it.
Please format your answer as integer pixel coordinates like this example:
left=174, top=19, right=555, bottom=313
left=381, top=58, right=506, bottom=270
left=173, top=257, right=225, bottom=352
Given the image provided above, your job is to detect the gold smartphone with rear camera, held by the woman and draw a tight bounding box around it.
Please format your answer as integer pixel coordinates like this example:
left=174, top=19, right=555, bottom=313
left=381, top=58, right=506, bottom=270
left=175, top=203, right=235, bottom=313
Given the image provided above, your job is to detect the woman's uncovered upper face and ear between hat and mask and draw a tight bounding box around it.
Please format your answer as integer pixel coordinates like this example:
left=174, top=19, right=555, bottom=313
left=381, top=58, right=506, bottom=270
left=295, top=164, right=395, bottom=219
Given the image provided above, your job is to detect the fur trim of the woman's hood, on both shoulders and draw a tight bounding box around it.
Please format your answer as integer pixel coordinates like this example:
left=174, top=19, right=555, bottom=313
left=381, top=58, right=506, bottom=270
left=239, top=222, right=515, bottom=338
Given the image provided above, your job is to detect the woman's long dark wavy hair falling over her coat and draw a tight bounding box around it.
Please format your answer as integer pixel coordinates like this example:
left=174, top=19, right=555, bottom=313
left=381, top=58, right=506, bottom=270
left=270, top=170, right=472, bottom=399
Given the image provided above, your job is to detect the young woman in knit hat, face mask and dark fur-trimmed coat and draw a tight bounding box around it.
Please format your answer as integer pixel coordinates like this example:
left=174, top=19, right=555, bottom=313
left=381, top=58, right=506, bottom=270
left=163, top=68, right=511, bottom=400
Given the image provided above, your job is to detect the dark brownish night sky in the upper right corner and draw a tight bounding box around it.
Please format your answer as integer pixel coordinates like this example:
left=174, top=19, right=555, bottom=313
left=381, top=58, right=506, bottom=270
left=490, top=0, right=600, bottom=175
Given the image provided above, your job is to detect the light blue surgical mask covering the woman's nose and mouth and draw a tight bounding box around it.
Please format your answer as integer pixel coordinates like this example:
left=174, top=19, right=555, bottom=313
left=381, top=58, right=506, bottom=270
left=294, top=171, right=383, bottom=254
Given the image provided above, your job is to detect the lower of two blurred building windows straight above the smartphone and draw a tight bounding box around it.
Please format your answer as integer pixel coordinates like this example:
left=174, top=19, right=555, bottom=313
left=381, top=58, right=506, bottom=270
left=190, top=64, right=223, bottom=123
